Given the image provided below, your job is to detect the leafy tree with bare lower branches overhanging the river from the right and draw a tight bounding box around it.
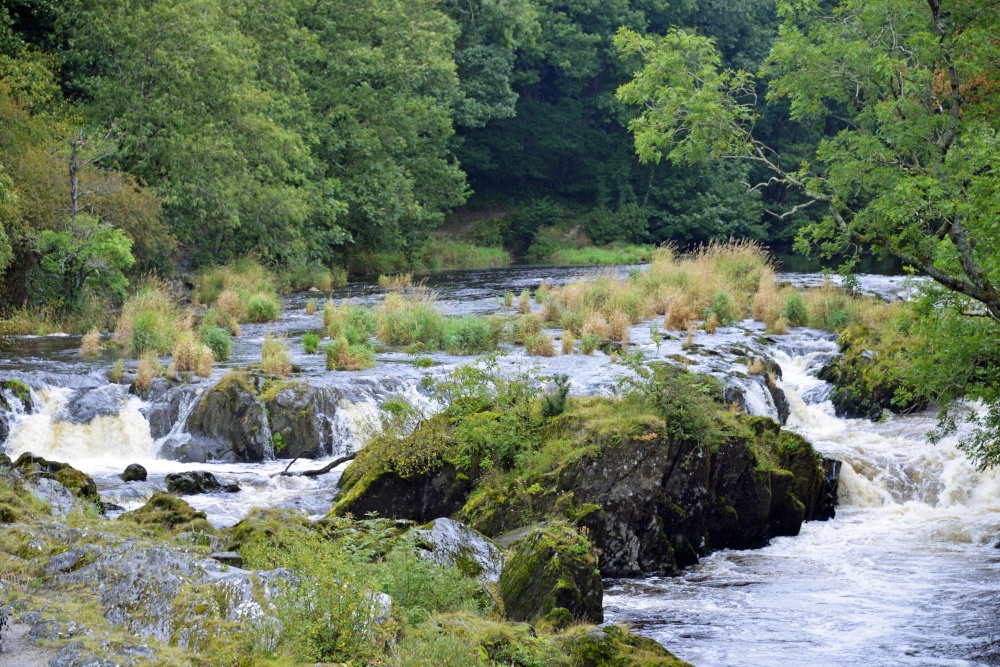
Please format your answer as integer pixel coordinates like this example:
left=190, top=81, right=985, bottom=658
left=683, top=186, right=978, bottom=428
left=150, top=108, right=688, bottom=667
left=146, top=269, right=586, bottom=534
left=616, top=0, right=1000, bottom=465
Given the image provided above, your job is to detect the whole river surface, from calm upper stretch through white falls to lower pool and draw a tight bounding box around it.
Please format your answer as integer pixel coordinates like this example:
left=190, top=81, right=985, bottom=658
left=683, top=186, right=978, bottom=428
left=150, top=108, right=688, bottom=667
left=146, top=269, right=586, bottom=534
left=0, top=267, right=1000, bottom=667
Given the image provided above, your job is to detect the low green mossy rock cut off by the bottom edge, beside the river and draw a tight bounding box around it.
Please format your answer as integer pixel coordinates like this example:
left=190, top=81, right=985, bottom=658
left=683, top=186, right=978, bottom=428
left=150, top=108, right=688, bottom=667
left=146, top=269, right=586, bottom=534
left=556, top=625, right=691, bottom=667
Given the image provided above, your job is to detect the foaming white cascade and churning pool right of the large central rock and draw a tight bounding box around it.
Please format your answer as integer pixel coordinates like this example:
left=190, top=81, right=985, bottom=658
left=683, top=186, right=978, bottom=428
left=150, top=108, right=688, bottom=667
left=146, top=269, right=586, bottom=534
left=604, top=337, right=1000, bottom=667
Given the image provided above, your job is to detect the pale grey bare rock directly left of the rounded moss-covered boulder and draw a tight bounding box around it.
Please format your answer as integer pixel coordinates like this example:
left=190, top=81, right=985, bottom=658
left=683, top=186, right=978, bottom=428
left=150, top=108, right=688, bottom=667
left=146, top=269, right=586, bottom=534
left=411, top=518, right=504, bottom=583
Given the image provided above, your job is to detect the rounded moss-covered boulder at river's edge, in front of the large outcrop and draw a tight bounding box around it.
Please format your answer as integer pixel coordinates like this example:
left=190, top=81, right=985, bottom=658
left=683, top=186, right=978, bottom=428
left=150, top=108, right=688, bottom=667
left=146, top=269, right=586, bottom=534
left=500, top=521, right=604, bottom=623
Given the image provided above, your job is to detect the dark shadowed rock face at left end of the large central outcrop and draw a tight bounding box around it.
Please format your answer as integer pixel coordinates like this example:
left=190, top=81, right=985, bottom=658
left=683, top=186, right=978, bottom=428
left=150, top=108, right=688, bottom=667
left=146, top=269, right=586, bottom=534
left=331, top=463, right=472, bottom=523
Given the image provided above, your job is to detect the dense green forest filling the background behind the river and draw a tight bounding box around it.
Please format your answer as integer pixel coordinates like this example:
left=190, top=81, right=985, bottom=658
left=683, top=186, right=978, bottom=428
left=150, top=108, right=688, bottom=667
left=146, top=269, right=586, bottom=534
left=0, top=0, right=823, bottom=308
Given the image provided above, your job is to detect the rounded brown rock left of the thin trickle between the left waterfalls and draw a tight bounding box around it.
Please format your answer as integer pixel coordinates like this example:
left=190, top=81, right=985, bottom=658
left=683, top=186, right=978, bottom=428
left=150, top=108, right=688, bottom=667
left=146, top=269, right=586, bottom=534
left=187, top=379, right=273, bottom=463
